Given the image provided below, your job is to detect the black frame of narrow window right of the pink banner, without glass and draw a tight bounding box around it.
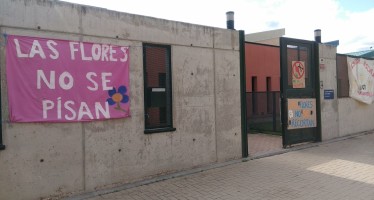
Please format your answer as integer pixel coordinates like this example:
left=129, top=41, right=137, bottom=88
left=143, top=43, right=176, bottom=134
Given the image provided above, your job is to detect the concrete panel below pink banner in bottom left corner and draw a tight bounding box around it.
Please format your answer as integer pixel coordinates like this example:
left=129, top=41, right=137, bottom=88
left=0, top=123, right=84, bottom=200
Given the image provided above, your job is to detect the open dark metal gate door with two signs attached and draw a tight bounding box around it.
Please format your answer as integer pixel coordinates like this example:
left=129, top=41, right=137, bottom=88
left=280, top=37, right=321, bottom=147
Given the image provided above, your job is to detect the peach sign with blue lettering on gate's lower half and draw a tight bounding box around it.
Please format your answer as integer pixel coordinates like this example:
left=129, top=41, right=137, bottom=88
left=287, top=99, right=317, bottom=130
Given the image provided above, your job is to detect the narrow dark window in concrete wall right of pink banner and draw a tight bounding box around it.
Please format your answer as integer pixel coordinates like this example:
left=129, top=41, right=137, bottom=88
left=143, top=44, right=175, bottom=133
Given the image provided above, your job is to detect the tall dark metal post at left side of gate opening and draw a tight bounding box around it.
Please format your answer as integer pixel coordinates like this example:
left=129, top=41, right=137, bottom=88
left=239, top=30, right=248, bottom=158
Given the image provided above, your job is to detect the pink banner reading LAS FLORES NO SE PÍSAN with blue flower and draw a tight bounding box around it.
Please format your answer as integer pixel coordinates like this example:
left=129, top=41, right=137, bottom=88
left=6, top=35, right=130, bottom=122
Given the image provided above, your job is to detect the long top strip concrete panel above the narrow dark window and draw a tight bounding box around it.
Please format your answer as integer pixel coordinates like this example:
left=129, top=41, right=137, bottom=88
left=82, top=7, right=213, bottom=47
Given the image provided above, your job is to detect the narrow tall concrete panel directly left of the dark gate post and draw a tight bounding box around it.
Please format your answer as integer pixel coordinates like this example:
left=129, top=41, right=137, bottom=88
left=215, top=50, right=241, bottom=161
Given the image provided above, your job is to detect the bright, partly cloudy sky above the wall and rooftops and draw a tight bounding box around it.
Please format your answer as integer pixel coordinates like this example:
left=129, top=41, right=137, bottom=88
left=60, top=0, right=374, bottom=53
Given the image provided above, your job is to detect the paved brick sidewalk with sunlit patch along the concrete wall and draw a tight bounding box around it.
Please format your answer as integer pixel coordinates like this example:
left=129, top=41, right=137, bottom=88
left=71, top=134, right=374, bottom=200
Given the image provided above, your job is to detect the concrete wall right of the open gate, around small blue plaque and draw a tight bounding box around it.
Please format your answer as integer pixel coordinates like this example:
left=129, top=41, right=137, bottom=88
left=319, top=44, right=374, bottom=140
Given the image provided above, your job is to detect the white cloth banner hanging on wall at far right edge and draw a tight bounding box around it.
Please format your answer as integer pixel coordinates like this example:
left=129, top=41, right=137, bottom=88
left=347, top=57, right=374, bottom=104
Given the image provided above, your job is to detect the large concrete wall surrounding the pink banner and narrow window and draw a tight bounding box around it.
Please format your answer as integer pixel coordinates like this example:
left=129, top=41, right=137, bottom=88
left=0, top=0, right=241, bottom=199
